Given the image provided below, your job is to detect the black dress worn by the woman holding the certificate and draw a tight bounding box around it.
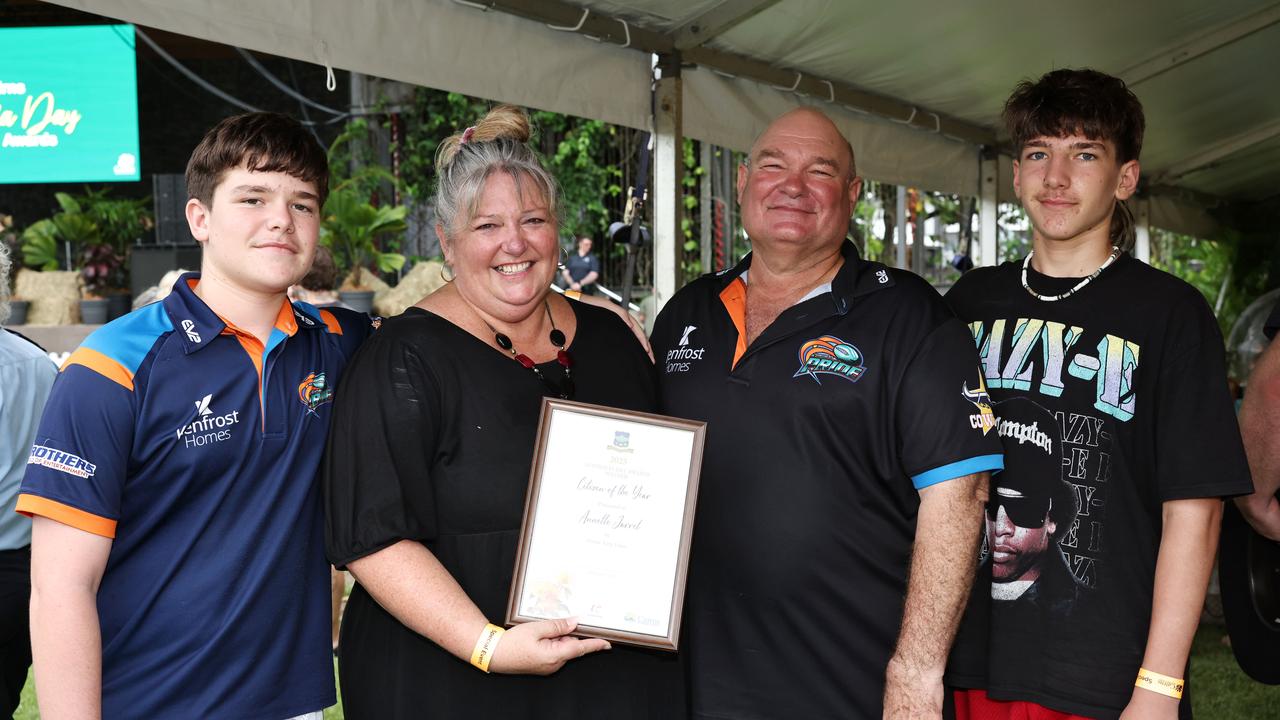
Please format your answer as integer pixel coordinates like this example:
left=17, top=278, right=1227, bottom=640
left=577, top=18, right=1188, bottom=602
left=323, top=302, right=686, bottom=720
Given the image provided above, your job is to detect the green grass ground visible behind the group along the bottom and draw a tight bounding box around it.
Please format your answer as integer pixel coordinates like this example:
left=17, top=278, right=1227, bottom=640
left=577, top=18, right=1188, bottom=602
left=14, top=623, right=1280, bottom=720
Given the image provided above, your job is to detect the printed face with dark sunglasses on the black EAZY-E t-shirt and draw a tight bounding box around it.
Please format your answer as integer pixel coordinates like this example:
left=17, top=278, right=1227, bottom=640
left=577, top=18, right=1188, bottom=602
left=987, top=487, right=1057, bottom=583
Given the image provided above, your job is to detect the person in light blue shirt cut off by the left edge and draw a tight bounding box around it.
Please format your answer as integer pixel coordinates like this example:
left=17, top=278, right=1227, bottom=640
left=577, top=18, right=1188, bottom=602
left=0, top=242, right=58, bottom=717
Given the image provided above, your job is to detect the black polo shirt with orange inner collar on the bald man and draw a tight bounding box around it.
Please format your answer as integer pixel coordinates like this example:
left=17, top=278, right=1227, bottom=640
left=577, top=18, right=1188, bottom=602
left=653, top=242, right=1004, bottom=719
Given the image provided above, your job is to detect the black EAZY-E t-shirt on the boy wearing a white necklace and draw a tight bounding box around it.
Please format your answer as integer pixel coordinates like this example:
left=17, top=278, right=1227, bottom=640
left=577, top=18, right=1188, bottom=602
left=946, top=255, right=1252, bottom=719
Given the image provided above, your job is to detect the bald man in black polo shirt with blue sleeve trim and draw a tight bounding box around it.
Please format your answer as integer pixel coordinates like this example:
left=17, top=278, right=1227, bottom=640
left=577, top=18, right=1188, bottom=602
left=653, top=109, right=1002, bottom=719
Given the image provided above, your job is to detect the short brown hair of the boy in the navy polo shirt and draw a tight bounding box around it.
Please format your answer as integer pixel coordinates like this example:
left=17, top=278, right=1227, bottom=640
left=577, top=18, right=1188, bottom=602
left=187, top=113, right=329, bottom=206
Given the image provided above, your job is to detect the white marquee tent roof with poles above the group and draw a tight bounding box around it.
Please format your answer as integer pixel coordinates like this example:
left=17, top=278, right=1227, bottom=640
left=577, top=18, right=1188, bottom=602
left=40, top=0, right=1280, bottom=300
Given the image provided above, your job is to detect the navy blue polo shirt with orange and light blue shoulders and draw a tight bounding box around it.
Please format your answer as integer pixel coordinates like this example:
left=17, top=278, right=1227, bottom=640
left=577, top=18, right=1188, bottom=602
left=18, top=273, right=370, bottom=720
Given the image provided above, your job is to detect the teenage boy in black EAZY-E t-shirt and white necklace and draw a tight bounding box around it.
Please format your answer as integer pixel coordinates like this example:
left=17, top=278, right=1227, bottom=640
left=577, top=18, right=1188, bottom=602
left=947, top=70, right=1252, bottom=720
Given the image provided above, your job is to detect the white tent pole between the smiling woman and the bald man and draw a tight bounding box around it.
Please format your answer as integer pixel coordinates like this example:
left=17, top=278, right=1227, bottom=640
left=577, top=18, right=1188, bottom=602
left=653, top=54, right=685, bottom=311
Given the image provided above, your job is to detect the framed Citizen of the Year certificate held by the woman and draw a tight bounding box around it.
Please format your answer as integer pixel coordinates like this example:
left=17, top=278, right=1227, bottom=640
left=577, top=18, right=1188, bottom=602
left=507, top=398, right=707, bottom=651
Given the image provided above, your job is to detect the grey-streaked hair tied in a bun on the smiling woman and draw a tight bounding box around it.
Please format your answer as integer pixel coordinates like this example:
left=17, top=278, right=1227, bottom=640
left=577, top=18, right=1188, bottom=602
left=435, top=105, right=559, bottom=237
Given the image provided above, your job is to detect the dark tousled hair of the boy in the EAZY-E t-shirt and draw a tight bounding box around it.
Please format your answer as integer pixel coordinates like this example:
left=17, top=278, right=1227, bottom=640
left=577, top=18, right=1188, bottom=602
left=1004, top=69, right=1147, bottom=164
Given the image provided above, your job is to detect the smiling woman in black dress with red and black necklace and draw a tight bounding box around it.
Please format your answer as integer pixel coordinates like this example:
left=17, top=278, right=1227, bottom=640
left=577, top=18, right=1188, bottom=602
left=323, top=106, right=685, bottom=720
